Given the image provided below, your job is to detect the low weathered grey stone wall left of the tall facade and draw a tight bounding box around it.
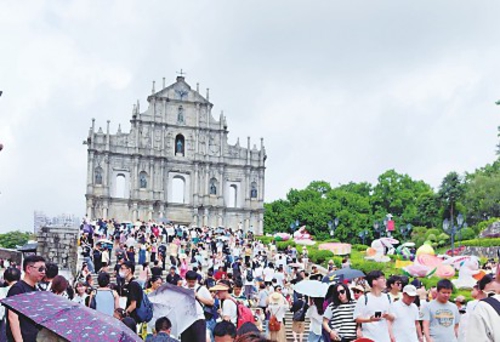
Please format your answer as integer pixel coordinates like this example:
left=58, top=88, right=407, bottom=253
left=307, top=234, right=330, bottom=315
left=36, top=227, right=78, bottom=271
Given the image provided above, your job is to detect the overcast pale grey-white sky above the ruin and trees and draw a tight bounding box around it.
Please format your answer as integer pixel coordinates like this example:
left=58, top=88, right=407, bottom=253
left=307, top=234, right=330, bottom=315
left=0, top=0, right=500, bottom=232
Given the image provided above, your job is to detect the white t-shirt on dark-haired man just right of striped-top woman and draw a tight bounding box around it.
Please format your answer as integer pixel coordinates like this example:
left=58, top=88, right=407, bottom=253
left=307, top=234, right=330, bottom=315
left=354, top=293, right=391, bottom=342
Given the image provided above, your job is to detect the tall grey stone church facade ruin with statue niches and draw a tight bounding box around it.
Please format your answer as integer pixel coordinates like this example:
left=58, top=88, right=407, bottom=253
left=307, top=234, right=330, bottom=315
left=85, top=75, right=267, bottom=234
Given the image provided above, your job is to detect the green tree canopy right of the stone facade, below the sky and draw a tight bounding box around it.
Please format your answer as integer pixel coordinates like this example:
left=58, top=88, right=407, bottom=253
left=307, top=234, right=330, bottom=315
left=264, top=159, right=500, bottom=244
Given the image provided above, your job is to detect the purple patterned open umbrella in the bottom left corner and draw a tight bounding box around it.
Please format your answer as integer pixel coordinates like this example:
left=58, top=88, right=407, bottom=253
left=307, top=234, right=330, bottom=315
left=0, top=291, right=142, bottom=342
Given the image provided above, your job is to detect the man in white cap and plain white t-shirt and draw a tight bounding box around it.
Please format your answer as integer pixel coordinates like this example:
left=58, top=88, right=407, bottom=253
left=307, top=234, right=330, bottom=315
left=391, top=285, right=423, bottom=342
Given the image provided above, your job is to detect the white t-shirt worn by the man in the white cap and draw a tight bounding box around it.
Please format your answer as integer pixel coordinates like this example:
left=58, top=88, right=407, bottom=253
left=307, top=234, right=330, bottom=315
left=391, top=300, right=419, bottom=342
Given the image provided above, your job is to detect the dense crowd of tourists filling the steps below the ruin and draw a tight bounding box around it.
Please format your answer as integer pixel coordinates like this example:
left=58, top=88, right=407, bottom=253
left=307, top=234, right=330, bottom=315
left=0, top=220, right=500, bottom=342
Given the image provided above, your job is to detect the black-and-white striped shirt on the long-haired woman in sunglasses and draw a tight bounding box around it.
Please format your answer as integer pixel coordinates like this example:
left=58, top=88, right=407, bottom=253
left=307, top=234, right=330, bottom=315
left=323, top=301, right=356, bottom=339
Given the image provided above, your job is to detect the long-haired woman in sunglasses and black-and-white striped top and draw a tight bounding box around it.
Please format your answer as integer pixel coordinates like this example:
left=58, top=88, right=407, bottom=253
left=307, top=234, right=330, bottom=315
left=323, top=283, right=356, bottom=342
